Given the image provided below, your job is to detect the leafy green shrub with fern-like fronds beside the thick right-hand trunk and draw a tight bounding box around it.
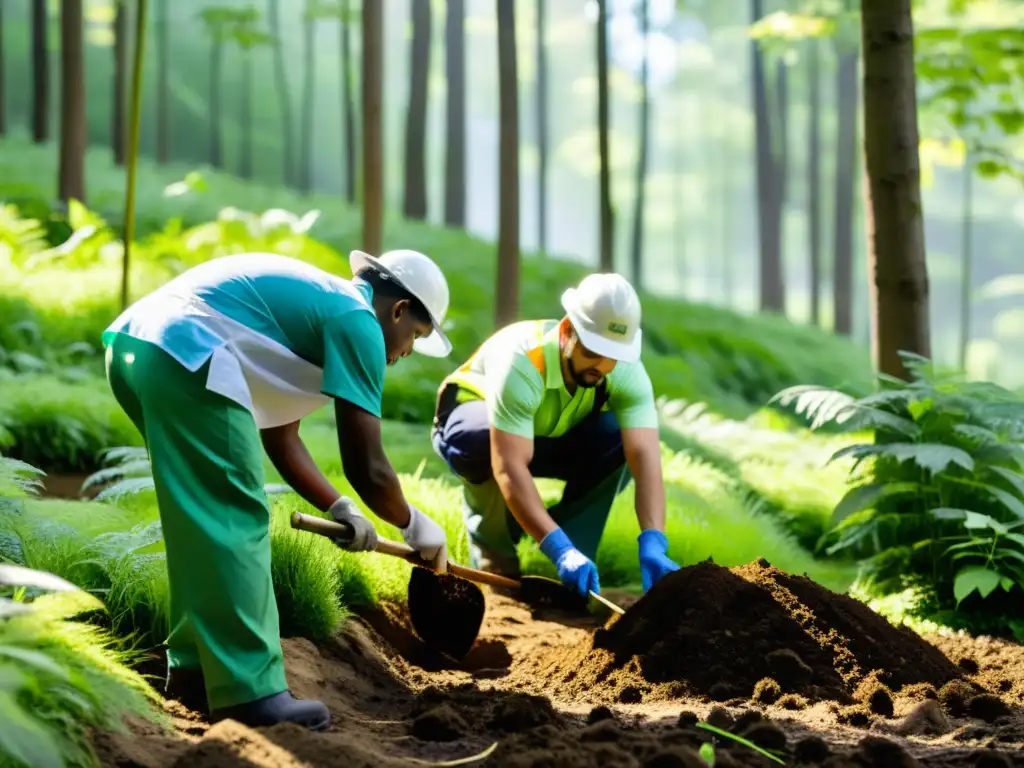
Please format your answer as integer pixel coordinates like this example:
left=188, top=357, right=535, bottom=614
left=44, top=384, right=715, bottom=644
left=777, top=354, right=1024, bottom=636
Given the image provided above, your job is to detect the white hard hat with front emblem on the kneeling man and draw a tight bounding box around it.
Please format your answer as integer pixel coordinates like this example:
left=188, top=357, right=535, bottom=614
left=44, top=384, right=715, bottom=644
left=562, top=273, right=642, bottom=362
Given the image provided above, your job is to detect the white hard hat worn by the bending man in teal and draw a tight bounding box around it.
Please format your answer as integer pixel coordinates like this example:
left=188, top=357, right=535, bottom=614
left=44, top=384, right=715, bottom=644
left=348, top=249, right=452, bottom=357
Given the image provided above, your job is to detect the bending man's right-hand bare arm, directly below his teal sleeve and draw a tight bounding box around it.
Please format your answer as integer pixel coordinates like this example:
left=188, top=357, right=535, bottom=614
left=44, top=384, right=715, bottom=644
left=334, top=398, right=411, bottom=528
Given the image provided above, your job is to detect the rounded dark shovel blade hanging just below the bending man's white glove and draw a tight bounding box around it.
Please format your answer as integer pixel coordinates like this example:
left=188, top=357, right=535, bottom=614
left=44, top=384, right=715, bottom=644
left=409, top=567, right=484, bottom=659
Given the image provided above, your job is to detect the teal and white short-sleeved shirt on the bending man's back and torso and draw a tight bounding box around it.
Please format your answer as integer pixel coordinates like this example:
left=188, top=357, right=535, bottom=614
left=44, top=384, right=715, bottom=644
left=102, top=253, right=387, bottom=428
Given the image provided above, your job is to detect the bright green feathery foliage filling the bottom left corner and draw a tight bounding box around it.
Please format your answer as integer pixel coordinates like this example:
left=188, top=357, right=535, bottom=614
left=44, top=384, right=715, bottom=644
left=0, top=552, right=168, bottom=768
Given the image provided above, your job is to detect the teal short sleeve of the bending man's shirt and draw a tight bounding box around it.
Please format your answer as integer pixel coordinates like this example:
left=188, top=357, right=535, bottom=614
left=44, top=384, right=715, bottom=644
left=321, top=310, right=387, bottom=419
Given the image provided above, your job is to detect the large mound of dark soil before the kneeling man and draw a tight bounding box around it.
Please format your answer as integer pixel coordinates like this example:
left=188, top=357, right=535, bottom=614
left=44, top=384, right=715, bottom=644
left=518, top=560, right=963, bottom=715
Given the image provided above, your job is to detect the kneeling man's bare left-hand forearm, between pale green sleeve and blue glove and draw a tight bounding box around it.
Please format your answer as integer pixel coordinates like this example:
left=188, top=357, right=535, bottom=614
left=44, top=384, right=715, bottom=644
left=490, top=425, right=558, bottom=542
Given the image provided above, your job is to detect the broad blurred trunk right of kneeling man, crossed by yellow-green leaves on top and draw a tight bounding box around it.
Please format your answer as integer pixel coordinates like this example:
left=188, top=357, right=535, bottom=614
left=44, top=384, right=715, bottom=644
left=751, top=0, right=785, bottom=311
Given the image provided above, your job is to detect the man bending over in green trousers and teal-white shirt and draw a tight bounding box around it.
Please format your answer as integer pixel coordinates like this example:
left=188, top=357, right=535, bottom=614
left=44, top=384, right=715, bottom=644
left=102, top=251, right=451, bottom=730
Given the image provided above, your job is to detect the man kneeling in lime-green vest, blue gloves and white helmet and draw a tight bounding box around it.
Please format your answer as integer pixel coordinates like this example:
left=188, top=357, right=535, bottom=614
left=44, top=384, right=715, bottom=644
left=432, top=274, right=679, bottom=596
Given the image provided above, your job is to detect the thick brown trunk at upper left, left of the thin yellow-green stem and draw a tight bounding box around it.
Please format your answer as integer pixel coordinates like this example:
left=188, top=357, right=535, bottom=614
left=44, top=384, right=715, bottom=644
left=58, top=0, right=86, bottom=203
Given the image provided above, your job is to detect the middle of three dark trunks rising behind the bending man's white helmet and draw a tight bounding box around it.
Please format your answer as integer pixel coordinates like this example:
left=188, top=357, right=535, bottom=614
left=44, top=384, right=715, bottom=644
left=401, top=0, right=431, bottom=219
